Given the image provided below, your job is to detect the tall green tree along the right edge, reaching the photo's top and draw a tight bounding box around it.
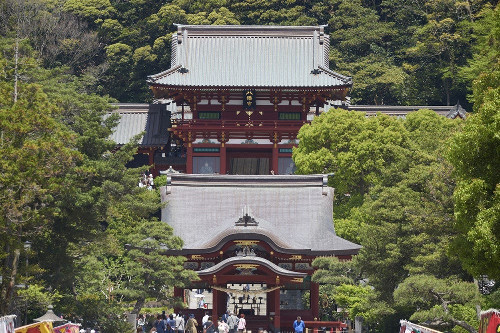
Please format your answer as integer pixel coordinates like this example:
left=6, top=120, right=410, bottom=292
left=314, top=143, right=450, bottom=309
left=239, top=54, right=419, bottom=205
left=449, top=1, right=500, bottom=280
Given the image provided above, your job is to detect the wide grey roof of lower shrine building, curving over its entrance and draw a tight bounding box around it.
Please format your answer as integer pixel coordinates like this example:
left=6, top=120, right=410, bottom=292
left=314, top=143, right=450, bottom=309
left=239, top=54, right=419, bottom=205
left=162, top=174, right=360, bottom=255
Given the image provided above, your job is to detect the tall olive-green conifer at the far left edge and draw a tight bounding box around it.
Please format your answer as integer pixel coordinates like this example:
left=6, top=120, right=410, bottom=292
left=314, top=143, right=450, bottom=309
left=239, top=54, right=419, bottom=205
left=0, top=84, right=81, bottom=314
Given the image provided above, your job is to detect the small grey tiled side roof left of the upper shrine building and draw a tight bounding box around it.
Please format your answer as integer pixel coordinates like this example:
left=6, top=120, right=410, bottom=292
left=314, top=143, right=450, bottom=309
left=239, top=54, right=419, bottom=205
left=106, top=104, right=175, bottom=146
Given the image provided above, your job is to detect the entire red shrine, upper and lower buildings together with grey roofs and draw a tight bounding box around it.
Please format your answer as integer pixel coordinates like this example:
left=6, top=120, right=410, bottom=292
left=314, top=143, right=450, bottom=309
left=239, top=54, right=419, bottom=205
left=148, top=25, right=360, bottom=331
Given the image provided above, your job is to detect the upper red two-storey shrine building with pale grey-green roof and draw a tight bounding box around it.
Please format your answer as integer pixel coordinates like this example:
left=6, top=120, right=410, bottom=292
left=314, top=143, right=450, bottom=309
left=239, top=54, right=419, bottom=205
left=148, top=25, right=352, bottom=175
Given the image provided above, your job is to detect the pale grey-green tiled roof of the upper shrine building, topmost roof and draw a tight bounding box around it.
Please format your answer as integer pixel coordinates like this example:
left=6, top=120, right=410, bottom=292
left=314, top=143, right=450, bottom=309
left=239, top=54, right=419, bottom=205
left=149, top=25, right=352, bottom=88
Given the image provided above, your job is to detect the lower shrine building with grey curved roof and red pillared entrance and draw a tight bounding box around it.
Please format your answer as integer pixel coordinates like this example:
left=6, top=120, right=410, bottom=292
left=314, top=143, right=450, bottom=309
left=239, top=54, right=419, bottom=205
left=161, top=173, right=360, bottom=332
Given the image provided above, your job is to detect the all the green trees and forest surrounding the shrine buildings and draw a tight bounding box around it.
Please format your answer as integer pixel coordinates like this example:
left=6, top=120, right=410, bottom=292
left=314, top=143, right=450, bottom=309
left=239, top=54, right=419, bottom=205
left=0, top=0, right=500, bottom=332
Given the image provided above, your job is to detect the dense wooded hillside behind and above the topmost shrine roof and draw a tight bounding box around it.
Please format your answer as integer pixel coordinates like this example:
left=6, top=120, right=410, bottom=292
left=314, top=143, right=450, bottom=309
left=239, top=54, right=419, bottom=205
left=1, top=0, right=496, bottom=105
